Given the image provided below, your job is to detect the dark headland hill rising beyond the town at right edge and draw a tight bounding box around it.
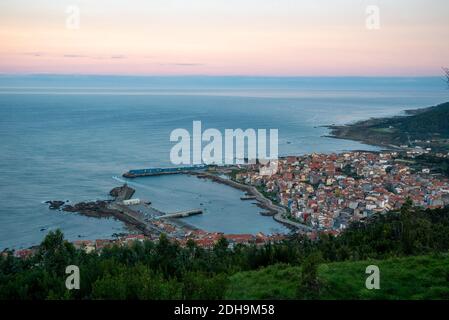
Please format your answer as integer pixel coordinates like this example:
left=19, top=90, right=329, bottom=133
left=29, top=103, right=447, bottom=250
left=329, top=102, right=449, bottom=151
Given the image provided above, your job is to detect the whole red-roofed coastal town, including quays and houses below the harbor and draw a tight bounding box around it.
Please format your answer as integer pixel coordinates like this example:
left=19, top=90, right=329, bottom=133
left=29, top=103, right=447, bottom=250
left=6, top=150, right=449, bottom=257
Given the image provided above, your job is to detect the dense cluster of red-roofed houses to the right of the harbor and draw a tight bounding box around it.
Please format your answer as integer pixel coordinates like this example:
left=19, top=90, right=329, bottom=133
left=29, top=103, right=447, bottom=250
left=235, top=151, right=449, bottom=235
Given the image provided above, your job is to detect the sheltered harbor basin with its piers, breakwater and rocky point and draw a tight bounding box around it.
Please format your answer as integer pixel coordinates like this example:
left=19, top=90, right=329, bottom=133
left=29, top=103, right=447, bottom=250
left=43, top=166, right=292, bottom=242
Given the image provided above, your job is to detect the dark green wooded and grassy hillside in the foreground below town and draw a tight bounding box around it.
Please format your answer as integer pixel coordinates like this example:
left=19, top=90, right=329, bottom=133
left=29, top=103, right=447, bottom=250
left=0, top=201, right=449, bottom=300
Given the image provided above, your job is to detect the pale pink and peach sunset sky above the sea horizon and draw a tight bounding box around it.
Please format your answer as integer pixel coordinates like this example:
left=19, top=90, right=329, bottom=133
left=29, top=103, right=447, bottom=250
left=0, top=0, right=449, bottom=76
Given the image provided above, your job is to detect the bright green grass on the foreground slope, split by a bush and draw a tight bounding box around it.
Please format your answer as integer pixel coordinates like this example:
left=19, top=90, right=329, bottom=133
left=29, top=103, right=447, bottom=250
left=226, top=254, right=449, bottom=299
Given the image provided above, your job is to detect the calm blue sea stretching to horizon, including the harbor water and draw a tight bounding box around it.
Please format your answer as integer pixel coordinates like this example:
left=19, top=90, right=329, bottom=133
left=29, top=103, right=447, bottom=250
left=0, top=75, right=449, bottom=249
